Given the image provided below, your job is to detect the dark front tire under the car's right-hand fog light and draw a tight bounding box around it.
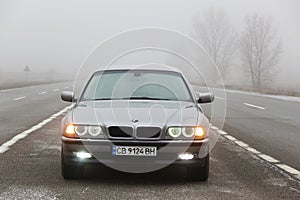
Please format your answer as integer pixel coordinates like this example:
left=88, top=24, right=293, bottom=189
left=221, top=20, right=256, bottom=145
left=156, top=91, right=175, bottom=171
left=187, top=155, right=209, bottom=181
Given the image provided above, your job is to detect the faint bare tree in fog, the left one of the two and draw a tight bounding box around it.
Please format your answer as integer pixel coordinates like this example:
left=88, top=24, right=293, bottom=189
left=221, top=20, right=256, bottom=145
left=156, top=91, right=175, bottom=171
left=193, top=8, right=237, bottom=77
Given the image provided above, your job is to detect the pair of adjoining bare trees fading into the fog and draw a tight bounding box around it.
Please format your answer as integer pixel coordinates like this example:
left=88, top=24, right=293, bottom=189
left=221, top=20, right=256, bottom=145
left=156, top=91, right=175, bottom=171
left=193, top=8, right=282, bottom=90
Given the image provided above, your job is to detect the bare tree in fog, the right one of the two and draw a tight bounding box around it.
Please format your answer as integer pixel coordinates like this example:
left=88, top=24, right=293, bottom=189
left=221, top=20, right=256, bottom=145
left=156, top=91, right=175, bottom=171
left=240, top=14, right=281, bottom=90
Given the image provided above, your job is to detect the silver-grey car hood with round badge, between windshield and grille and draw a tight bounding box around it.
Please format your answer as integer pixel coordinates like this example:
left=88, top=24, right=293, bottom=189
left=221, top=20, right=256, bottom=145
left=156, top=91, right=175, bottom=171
left=72, top=100, right=208, bottom=127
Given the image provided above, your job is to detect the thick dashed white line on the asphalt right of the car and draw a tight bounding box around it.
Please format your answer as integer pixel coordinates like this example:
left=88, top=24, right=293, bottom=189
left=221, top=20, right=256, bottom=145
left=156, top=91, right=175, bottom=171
left=216, top=126, right=300, bottom=180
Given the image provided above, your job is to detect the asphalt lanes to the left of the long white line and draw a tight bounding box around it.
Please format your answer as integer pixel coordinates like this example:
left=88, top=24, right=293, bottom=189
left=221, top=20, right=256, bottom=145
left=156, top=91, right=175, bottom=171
left=0, top=83, right=72, bottom=144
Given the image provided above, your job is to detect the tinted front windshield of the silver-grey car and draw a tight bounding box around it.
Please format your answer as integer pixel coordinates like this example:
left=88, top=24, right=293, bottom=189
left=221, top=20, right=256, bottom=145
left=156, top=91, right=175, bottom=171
left=81, top=70, right=192, bottom=101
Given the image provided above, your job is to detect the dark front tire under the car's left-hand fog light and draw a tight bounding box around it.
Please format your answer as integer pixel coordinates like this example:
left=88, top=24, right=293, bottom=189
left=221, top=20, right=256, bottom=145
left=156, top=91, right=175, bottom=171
left=61, top=151, right=84, bottom=179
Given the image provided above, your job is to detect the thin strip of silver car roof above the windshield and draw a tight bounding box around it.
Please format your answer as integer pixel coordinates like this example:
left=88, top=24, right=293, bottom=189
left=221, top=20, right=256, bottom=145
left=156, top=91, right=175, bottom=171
left=98, top=64, right=182, bottom=73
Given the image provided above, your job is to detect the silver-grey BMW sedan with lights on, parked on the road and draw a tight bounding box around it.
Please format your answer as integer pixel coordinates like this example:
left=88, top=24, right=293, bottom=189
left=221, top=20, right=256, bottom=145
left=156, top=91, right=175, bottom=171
left=61, top=64, right=214, bottom=181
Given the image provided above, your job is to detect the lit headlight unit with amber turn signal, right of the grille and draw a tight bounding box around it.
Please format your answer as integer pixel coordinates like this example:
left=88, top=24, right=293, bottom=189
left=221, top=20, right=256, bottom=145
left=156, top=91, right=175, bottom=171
left=167, top=126, right=206, bottom=140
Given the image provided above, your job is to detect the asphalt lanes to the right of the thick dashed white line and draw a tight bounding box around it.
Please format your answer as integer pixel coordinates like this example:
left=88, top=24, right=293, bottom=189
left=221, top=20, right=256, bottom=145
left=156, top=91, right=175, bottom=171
left=197, top=86, right=300, bottom=170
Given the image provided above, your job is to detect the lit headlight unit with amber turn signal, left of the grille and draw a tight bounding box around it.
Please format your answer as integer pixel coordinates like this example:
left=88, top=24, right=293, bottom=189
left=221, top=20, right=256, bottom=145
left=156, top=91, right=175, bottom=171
left=64, top=124, right=103, bottom=137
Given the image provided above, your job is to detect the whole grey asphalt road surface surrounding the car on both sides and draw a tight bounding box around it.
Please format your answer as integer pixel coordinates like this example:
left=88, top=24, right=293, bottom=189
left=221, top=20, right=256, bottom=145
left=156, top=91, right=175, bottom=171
left=0, top=83, right=300, bottom=199
